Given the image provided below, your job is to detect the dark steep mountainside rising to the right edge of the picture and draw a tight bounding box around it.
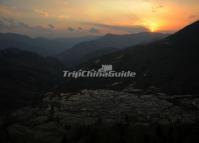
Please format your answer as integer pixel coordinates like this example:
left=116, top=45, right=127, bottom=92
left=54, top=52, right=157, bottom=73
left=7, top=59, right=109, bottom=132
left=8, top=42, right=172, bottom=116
left=79, top=21, right=199, bottom=94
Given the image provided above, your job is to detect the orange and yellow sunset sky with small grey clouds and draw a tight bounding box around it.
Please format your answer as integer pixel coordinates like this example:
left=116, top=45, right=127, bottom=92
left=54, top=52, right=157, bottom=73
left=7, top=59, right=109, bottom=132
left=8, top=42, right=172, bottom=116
left=0, top=0, right=199, bottom=38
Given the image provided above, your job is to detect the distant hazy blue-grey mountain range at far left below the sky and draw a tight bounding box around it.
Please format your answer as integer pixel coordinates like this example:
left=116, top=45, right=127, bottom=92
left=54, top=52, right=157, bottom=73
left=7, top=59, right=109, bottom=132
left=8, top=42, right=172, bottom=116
left=0, top=33, right=95, bottom=56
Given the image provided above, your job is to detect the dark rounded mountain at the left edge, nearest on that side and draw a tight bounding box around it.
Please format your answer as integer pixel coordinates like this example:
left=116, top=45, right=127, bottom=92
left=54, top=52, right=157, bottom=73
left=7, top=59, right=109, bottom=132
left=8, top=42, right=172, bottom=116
left=0, top=48, right=62, bottom=111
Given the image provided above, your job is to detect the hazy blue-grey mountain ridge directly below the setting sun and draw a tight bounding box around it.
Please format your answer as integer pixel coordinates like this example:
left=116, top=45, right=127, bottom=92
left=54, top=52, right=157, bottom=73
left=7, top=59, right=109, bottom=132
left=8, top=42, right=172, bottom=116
left=58, top=32, right=168, bottom=67
